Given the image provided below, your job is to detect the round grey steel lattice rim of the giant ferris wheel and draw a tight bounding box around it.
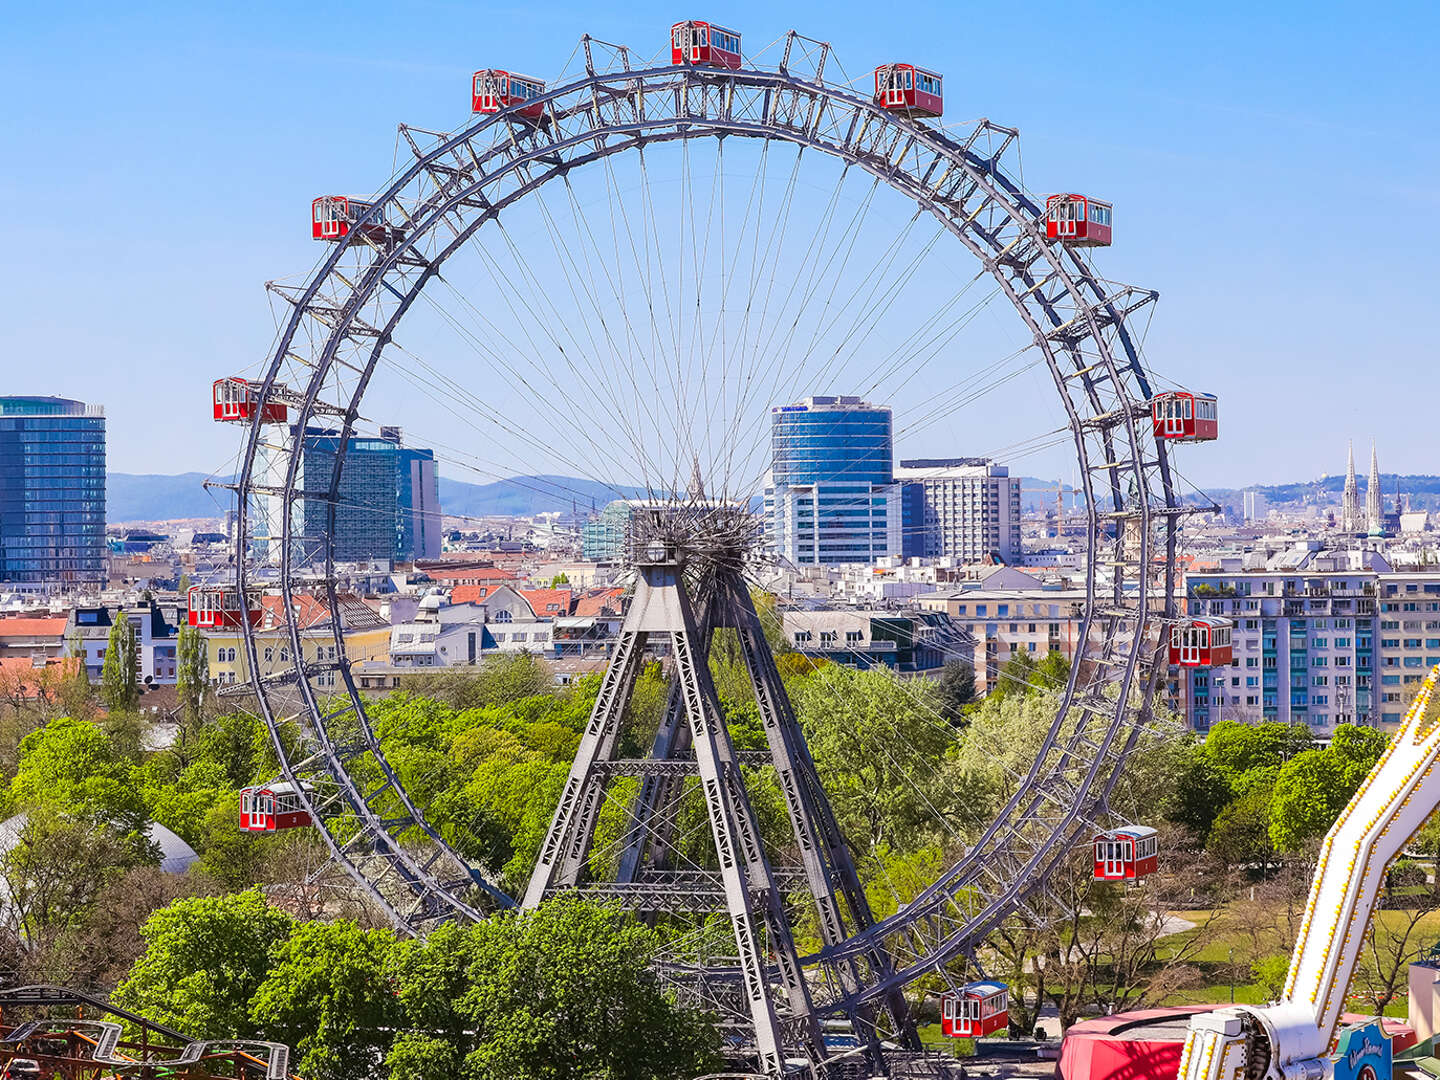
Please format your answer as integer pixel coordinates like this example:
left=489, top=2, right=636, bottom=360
left=236, top=38, right=1179, bottom=999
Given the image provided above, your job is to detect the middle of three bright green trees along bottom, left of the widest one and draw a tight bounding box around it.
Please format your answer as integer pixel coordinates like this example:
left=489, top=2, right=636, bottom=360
left=249, top=922, right=403, bottom=1080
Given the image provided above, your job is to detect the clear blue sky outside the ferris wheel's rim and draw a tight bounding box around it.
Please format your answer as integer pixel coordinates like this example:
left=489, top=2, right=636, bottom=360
left=0, top=0, right=1440, bottom=487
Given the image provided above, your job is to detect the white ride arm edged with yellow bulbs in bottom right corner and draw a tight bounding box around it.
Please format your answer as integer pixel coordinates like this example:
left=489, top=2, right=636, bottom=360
left=1179, top=667, right=1440, bottom=1080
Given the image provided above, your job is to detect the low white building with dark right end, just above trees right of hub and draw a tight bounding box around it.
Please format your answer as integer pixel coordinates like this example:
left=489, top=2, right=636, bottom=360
left=783, top=611, right=972, bottom=672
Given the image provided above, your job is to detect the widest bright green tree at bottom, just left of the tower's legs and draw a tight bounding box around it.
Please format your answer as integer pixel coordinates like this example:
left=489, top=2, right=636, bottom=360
left=387, top=897, right=719, bottom=1080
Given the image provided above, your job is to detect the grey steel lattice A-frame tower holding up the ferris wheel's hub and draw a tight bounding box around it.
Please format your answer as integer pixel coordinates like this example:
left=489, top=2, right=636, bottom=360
left=524, top=532, right=913, bottom=1076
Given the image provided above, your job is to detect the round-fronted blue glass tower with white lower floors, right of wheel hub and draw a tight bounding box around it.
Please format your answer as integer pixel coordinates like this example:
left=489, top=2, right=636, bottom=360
left=765, top=397, right=901, bottom=566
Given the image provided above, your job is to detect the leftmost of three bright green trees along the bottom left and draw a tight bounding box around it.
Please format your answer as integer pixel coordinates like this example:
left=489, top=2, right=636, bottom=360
left=112, top=890, right=295, bottom=1038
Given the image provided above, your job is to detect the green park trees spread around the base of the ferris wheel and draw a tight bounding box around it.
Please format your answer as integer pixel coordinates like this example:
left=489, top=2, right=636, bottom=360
left=0, top=639, right=1440, bottom=1080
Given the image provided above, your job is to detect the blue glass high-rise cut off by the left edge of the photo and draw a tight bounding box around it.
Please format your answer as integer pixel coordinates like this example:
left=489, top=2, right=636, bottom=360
left=0, top=397, right=105, bottom=588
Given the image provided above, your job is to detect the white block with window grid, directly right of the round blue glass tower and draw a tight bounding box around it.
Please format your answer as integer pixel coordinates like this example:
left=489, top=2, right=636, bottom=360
left=896, top=458, right=1024, bottom=563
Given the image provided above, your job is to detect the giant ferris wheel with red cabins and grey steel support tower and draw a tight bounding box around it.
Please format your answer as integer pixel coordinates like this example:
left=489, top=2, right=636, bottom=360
left=205, top=22, right=1224, bottom=1073
